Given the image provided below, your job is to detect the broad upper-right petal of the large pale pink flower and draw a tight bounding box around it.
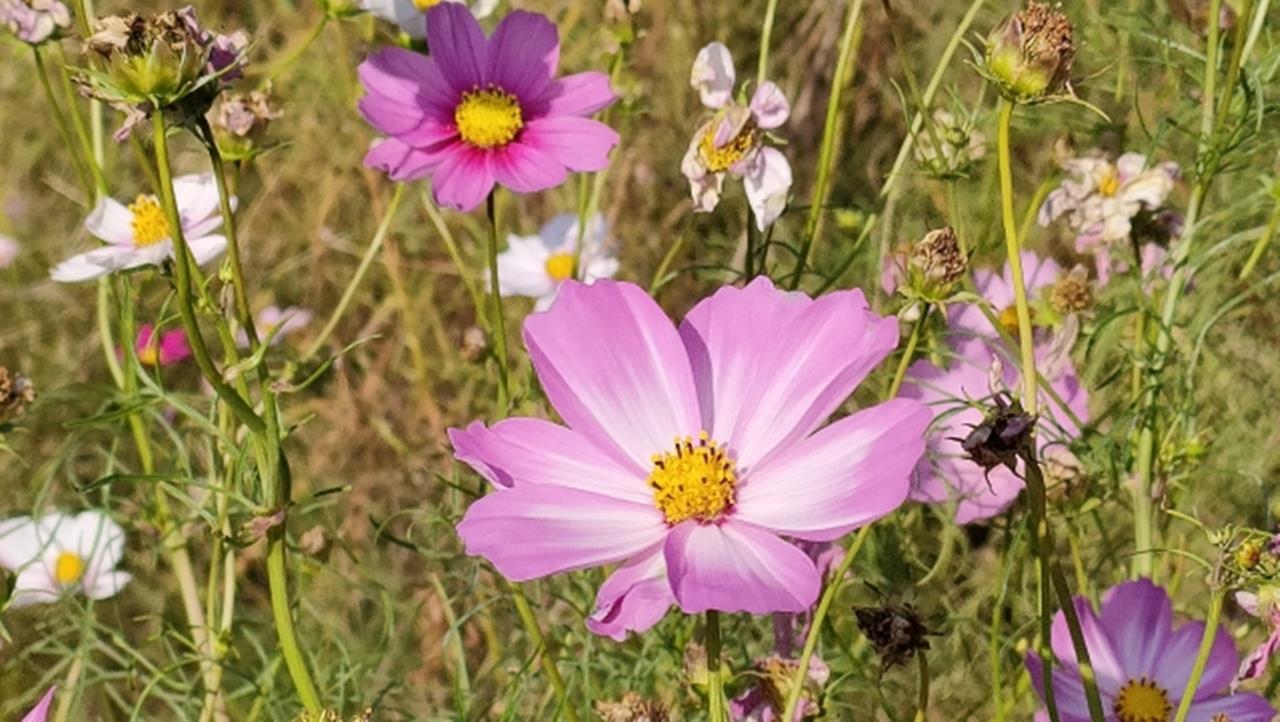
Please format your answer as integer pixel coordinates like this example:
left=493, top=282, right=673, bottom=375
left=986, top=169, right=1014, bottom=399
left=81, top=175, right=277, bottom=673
left=680, top=278, right=897, bottom=471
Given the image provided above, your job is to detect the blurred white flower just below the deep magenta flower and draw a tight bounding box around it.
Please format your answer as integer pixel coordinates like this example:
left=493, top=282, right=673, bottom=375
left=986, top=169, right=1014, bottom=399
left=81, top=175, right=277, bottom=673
left=498, top=214, right=618, bottom=311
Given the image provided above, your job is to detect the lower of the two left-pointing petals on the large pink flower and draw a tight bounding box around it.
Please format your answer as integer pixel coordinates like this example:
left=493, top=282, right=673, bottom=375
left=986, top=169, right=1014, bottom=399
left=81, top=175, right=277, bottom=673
left=458, top=484, right=667, bottom=581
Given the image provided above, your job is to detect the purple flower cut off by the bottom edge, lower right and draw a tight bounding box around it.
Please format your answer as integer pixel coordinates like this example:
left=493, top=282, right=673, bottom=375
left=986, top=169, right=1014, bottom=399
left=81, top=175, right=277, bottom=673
left=1027, top=579, right=1276, bottom=722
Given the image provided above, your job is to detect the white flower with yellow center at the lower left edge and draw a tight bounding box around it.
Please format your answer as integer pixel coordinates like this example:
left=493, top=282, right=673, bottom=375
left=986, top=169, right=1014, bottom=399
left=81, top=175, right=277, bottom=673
left=0, top=511, right=132, bottom=607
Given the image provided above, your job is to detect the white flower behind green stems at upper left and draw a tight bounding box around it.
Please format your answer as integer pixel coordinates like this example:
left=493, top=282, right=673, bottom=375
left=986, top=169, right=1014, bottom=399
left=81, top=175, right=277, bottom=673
left=50, top=173, right=234, bottom=283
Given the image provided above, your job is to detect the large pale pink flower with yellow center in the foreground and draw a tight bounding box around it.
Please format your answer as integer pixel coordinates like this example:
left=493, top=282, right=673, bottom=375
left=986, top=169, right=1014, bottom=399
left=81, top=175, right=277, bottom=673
left=449, top=278, right=929, bottom=639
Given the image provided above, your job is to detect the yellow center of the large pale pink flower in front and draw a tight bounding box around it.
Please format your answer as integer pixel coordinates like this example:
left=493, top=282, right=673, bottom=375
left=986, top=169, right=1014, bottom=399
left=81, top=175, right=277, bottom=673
left=649, top=431, right=737, bottom=526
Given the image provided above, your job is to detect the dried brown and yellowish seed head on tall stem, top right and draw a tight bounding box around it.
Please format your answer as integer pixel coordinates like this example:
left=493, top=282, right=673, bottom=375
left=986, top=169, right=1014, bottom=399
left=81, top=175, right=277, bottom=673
left=986, top=1, right=1075, bottom=102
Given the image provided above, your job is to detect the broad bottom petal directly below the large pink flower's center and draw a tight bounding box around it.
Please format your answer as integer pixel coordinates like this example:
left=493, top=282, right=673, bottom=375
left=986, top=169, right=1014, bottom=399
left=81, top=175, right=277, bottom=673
left=664, top=520, right=820, bottom=614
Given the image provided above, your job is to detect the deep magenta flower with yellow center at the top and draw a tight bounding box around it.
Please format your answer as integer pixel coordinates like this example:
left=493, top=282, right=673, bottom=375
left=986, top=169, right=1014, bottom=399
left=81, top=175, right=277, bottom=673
left=360, top=3, right=618, bottom=211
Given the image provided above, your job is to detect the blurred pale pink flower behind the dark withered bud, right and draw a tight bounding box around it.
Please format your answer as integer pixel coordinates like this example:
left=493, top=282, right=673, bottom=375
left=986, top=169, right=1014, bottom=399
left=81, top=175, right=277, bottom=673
left=902, top=338, right=1089, bottom=524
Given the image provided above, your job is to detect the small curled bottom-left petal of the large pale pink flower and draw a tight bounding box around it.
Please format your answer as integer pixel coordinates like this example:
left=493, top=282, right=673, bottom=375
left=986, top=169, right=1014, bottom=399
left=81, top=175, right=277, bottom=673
left=586, top=545, right=676, bottom=641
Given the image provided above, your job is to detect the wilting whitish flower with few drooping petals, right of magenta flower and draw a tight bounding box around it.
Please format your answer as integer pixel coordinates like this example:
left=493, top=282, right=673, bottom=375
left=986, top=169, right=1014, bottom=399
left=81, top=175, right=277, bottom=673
left=680, top=42, right=791, bottom=230
